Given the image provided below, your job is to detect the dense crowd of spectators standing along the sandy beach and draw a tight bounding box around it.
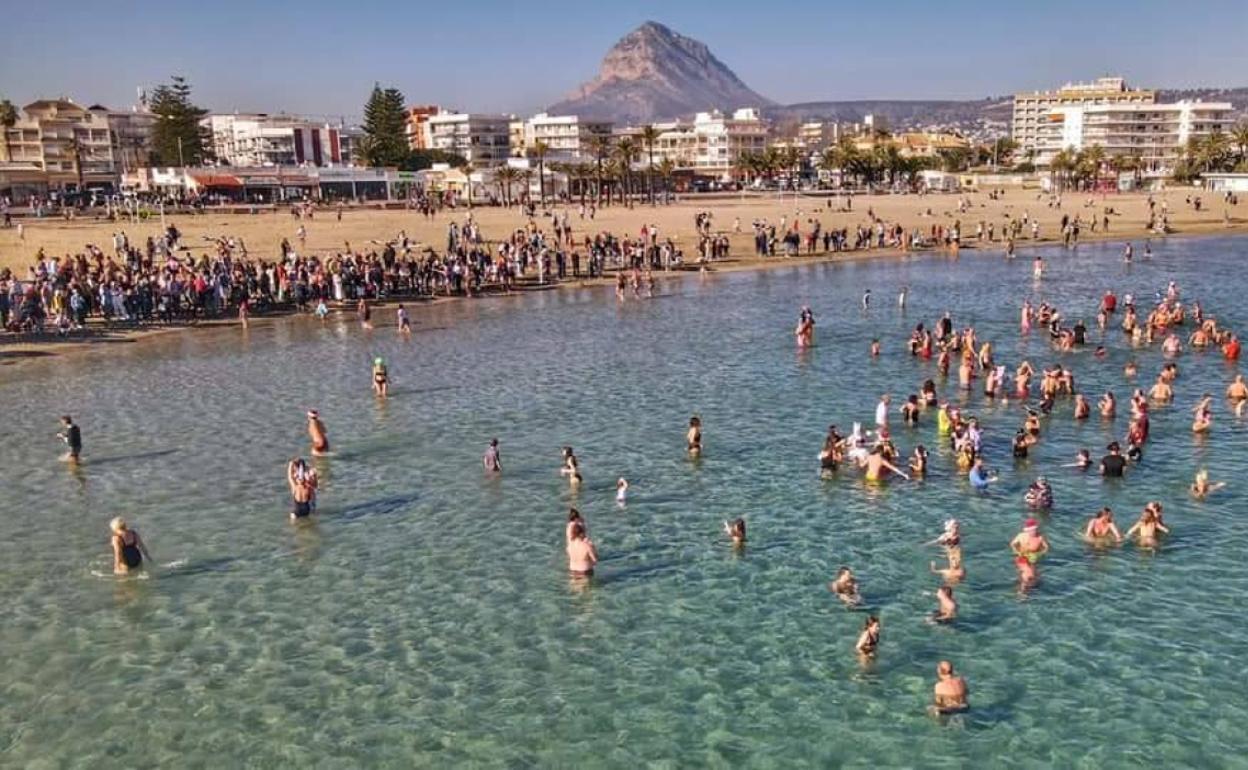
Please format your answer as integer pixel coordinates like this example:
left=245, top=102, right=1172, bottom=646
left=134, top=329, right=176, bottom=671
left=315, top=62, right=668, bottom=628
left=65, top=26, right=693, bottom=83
left=0, top=191, right=1208, bottom=336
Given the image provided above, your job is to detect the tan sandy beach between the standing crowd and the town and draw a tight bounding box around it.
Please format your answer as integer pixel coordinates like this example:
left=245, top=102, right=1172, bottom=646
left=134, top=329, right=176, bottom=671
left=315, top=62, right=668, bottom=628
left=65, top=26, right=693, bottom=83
left=0, top=188, right=1248, bottom=362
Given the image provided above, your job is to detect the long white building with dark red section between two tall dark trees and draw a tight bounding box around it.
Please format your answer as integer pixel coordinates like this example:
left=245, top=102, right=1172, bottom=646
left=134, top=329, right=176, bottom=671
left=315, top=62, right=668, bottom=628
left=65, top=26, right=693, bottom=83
left=200, top=114, right=353, bottom=168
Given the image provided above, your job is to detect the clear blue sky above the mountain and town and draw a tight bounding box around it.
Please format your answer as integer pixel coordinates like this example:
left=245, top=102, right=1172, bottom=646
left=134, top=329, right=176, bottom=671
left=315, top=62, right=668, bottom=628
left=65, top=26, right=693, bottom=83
left=0, top=0, right=1248, bottom=119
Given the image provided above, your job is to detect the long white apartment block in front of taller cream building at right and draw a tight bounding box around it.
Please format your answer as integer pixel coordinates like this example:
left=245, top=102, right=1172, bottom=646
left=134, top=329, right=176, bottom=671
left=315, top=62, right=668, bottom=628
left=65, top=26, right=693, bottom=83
left=1036, top=101, right=1234, bottom=176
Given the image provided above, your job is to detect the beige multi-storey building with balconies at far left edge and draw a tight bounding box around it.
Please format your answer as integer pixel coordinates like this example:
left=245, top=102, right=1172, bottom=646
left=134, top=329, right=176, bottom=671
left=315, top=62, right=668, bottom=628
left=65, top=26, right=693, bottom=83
left=2, top=99, right=116, bottom=188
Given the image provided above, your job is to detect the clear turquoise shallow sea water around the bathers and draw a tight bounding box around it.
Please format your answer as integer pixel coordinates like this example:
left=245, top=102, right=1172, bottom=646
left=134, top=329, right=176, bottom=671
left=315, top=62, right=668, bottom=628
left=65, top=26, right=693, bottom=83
left=0, top=238, right=1248, bottom=768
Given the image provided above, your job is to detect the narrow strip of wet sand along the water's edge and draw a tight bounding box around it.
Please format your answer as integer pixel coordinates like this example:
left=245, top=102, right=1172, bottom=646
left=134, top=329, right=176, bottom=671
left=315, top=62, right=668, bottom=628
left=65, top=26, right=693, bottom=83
left=0, top=220, right=1248, bottom=367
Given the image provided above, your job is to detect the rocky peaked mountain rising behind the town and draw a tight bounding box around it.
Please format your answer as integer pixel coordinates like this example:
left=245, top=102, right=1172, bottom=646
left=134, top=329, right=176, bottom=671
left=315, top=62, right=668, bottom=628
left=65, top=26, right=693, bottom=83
left=548, top=21, right=775, bottom=124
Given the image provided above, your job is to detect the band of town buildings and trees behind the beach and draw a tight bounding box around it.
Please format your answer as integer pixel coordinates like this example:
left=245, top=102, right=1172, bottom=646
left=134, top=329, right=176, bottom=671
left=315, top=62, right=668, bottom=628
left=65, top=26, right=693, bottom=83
left=0, top=77, right=1248, bottom=206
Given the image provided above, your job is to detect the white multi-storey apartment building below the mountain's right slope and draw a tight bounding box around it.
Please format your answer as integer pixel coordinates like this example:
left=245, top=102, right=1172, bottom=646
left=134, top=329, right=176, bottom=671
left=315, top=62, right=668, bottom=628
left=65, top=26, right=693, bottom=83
left=654, top=109, right=770, bottom=181
